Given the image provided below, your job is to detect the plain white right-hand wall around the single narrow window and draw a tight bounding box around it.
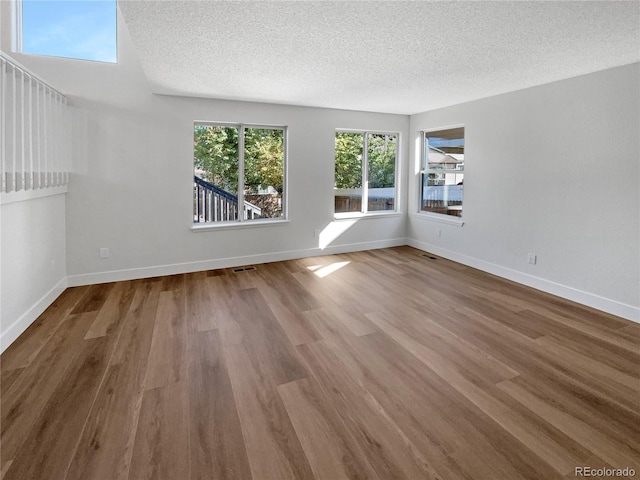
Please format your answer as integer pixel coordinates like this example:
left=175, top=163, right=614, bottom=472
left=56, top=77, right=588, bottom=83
left=407, top=64, right=640, bottom=320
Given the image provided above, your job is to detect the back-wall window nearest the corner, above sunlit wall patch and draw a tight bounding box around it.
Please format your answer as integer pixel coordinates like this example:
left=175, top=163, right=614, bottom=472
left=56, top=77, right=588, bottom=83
left=334, top=131, right=398, bottom=216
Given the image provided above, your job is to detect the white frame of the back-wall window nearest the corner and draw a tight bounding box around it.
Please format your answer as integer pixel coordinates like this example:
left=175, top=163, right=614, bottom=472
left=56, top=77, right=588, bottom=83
left=333, top=128, right=402, bottom=219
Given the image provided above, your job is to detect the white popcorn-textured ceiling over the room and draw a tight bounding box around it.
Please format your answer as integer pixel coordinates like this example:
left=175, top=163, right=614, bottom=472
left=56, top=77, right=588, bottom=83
left=119, top=0, right=640, bottom=114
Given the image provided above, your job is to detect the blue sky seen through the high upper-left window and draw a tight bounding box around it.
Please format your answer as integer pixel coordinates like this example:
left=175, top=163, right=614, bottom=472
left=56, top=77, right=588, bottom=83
left=22, top=0, right=117, bottom=62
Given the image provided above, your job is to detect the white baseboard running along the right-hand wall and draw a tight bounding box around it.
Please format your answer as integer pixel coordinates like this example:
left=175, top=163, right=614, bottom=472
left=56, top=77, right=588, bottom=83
left=407, top=238, right=640, bottom=323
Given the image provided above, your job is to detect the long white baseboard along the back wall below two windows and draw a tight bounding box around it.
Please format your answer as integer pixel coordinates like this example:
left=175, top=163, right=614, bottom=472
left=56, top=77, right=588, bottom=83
left=67, top=238, right=407, bottom=287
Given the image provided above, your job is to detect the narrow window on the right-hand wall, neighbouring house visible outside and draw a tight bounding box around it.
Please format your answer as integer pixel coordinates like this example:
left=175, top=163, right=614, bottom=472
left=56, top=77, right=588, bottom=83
left=420, top=127, right=464, bottom=217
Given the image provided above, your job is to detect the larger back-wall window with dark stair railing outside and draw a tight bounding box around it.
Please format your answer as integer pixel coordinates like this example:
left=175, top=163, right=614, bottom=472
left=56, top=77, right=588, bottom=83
left=193, top=123, right=286, bottom=223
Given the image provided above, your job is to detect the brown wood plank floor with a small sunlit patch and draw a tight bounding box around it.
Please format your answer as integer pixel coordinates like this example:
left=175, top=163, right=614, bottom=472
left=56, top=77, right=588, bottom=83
left=0, top=247, right=640, bottom=480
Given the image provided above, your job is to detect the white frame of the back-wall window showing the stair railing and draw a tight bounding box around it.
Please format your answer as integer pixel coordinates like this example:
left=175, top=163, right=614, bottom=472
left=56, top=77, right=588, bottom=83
left=191, top=120, right=289, bottom=231
